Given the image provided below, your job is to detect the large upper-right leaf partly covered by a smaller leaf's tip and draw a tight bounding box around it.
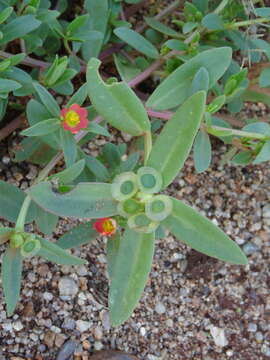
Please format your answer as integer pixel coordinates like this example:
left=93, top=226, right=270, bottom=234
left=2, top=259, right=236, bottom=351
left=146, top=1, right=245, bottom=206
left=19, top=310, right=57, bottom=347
left=146, top=47, right=232, bottom=110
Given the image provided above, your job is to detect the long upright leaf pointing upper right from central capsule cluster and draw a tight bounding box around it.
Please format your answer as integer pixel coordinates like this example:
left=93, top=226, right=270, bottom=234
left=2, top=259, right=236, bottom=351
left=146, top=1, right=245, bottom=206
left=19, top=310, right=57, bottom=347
left=146, top=91, right=205, bottom=189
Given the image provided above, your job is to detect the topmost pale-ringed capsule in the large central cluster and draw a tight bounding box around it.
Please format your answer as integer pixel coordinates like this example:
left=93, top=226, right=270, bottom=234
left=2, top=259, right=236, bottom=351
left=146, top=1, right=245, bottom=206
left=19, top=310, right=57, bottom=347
left=137, top=166, right=162, bottom=194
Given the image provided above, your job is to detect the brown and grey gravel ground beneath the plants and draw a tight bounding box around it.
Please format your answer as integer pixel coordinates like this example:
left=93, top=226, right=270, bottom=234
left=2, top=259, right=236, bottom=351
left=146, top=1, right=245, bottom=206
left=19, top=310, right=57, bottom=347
left=0, top=132, right=270, bottom=360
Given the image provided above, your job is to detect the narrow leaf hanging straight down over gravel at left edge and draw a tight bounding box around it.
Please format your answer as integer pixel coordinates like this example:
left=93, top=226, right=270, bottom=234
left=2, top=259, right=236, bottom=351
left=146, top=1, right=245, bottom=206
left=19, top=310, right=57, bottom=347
left=2, top=248, right=22, bottom=316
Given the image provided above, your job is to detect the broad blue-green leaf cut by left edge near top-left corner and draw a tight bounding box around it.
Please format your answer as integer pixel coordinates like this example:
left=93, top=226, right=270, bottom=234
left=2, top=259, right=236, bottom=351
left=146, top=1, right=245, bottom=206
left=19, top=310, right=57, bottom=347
left=0, top=15, right=41, bottom=45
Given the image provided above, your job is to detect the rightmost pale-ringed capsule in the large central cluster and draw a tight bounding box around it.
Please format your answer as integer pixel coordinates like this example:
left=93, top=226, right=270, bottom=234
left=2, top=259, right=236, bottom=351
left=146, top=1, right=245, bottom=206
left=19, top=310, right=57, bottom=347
left=145, top=195, right=173, bottom=221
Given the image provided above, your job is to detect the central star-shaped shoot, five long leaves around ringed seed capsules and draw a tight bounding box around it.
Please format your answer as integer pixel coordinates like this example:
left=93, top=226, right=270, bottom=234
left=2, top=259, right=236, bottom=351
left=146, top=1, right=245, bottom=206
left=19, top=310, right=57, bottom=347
left=14, top=55, right=247, bottom=326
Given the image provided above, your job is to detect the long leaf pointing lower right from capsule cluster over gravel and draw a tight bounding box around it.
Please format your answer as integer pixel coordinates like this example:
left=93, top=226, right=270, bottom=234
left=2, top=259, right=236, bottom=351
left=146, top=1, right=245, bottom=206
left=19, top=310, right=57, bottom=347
left=162, top=198, right=247, bottom=265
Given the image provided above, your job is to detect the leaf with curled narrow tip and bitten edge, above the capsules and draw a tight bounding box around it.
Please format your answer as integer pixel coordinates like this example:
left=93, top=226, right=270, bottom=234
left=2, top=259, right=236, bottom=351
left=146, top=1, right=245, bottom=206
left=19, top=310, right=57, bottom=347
left=87, top=59, right=150, bottom=136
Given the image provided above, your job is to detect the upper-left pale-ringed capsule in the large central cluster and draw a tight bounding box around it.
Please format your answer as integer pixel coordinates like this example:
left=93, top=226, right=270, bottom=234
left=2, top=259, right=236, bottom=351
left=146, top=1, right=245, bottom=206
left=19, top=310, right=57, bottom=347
left=112, top=171, right=138, bottom=201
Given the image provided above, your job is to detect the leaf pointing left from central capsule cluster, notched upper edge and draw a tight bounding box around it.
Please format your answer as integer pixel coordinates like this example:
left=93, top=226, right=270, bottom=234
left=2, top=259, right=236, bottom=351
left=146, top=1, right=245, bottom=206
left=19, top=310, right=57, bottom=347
left=28, top=182, right=117, bottom=219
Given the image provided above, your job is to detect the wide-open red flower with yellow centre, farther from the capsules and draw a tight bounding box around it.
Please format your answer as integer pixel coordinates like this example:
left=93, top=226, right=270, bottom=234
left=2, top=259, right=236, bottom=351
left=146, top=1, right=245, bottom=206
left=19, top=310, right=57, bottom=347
left=61, top=104, right=89, bottom=134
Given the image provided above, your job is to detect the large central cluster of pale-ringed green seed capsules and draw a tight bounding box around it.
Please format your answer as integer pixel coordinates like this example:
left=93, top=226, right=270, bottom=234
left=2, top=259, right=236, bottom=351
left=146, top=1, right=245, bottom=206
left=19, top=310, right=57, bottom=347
left=112, top=166, right=172, bottom=234
